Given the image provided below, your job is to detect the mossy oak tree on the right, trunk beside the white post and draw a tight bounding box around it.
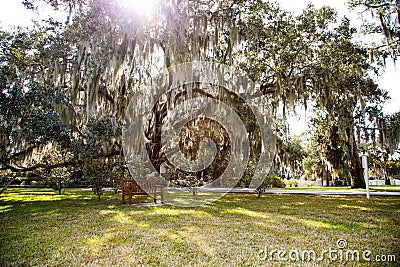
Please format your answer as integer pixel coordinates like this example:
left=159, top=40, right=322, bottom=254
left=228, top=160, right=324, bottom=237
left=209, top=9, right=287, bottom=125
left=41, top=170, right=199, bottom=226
left=242, top=6, right=385, bottom=188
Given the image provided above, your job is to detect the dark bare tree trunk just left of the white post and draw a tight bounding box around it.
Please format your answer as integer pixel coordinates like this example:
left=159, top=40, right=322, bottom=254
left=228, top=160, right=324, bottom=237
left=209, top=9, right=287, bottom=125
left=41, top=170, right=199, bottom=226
left=347, top=128, right=365, bottom=188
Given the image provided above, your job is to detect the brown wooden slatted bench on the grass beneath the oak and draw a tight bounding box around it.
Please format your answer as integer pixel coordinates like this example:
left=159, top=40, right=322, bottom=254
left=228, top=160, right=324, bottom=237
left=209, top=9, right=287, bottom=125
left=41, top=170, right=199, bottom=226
left=121, top=179, right=164, bottom=204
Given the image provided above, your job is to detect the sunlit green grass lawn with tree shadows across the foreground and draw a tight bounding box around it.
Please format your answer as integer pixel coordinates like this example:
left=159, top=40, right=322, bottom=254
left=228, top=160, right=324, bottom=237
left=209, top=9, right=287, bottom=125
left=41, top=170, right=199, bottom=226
left=0, top=189, right=400, bottom=266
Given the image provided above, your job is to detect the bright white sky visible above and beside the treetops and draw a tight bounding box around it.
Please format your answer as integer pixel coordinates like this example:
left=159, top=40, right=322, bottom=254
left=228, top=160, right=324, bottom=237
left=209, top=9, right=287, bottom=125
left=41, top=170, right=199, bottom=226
left=0, top=0, right=400, bottom=116
